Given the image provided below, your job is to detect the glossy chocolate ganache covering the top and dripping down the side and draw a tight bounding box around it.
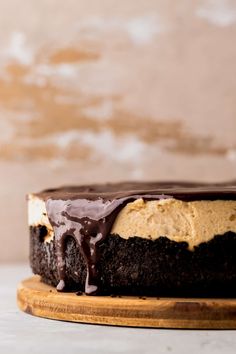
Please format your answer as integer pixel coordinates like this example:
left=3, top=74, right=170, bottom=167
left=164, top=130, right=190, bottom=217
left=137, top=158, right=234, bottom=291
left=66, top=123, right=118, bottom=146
left=38, top=182, right=236, bottom=295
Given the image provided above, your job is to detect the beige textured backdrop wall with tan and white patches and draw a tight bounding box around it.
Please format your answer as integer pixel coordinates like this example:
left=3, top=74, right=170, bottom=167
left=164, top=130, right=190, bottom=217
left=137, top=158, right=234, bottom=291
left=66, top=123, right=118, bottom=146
left=0, top=0, right=236, bottom=261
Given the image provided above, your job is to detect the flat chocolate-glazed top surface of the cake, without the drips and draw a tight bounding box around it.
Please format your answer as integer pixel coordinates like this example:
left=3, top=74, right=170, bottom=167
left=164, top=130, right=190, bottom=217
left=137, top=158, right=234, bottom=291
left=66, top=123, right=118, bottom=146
left=32, top=181, right=236, bottom=201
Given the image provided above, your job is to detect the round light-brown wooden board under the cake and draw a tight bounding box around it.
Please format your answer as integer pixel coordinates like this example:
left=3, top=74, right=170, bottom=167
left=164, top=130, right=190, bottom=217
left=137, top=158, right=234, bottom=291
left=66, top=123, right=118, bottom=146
left=17, top=276, right=236, bottom=329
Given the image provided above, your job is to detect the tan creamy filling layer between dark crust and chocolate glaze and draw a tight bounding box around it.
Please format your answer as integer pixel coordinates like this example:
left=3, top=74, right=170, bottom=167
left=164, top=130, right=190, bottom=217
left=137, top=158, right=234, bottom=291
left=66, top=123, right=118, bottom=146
left=29, top=195, right=236, bottom=249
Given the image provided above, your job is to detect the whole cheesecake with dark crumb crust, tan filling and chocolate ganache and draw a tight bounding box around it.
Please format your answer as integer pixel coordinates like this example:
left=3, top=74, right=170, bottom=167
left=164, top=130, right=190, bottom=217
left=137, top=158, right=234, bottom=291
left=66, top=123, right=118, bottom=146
left=28, top=182, right=236, bottom=297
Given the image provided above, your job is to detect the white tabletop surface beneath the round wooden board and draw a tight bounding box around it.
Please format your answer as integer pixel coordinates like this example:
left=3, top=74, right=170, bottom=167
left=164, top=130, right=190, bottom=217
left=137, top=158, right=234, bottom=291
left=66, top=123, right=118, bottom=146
left=0, top=265, right=236, bottom=354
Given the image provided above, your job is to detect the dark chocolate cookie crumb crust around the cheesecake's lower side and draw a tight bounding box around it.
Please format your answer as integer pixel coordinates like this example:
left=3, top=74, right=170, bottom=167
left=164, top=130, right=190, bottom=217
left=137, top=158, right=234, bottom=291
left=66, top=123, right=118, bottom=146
left=30, top=226, right=236, bottom=297
